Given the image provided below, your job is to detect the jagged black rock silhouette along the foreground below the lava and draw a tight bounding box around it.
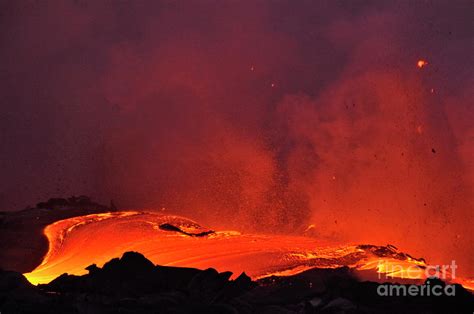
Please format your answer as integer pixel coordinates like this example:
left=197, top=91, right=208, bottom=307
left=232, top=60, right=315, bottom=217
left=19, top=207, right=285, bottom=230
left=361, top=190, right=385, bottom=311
left=0, top=252, right=474, bottom=314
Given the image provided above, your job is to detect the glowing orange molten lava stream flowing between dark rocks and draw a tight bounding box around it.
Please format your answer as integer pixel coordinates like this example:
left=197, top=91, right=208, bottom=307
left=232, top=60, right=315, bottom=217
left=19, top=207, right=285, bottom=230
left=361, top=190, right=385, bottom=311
left=25, top=211, right=474, bottom=290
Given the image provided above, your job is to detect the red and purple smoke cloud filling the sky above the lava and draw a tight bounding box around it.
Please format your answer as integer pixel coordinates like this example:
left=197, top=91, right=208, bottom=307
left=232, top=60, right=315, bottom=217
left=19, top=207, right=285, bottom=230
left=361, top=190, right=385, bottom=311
left=0, top=1, right=474, bottom=269
